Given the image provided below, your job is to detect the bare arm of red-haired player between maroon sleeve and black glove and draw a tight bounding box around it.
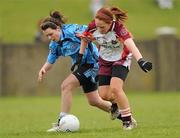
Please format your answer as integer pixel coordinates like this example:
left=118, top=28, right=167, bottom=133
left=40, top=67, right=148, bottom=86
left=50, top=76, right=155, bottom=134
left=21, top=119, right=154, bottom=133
left=124, top=38, right=142, bottom=61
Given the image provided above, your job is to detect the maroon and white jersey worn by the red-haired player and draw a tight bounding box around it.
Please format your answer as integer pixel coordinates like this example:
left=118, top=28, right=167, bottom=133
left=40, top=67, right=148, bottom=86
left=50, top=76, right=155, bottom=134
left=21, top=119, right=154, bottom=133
left=84, top=21, right=132, bottom=62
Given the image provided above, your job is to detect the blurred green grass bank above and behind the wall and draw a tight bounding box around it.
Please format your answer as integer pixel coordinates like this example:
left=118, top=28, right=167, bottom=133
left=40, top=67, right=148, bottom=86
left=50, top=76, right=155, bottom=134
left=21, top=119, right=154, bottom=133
left=0, top=0, right=180, bottom=43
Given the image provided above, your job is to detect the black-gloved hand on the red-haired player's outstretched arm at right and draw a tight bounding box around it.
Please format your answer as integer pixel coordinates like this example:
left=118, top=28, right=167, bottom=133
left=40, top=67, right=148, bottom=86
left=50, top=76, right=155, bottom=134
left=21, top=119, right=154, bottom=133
left=138, top=58, right=152, bottom=72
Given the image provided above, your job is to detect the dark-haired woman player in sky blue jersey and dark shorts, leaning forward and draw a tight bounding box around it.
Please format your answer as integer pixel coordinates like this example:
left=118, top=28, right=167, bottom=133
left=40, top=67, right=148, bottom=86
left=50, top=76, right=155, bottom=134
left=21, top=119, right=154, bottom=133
left=38, top=11, right=118, bottom=132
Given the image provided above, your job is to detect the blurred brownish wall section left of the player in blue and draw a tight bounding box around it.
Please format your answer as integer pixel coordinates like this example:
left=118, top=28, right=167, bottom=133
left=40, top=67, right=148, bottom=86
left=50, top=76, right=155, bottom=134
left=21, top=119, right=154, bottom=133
left=0, top=44, right=70, bottom=95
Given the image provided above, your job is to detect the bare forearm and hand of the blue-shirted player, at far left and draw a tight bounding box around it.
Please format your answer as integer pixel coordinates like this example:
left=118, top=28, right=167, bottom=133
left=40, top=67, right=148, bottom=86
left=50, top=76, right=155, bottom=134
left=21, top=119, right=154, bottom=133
left=38, top=62, right=53, bottom=82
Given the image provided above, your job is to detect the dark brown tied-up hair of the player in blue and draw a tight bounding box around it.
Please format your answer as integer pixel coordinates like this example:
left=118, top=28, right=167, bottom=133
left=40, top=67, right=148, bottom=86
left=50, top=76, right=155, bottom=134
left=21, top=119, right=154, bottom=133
left=40, top=11, right=66, bottom=31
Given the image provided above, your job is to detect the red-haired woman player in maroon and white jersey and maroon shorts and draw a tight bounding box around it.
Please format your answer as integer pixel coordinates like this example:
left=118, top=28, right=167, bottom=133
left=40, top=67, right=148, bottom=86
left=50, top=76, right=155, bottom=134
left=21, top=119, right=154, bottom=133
left=76, top=7, right=152, bottom=130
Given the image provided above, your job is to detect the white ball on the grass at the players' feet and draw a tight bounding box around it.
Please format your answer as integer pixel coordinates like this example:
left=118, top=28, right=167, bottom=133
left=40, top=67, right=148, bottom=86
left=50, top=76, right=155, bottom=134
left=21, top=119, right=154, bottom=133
left=59, top=114, right=80, bottom=132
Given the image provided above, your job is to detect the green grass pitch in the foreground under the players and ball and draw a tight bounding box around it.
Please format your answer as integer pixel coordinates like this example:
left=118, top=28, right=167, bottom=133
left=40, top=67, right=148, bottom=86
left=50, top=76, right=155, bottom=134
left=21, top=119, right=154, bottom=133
left=0, top=92, right=180, bottom=138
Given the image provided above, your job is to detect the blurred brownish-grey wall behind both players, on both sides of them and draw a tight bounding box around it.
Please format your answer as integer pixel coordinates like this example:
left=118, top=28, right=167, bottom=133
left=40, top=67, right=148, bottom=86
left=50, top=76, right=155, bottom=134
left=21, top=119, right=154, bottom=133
left=0, top=35, right=180, bottom=96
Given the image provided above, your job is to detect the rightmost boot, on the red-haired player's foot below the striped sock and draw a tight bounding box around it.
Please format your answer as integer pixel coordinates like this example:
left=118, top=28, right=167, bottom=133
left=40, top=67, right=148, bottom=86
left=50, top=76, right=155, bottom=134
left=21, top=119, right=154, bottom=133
left=123, top=117, right=137, bottom=130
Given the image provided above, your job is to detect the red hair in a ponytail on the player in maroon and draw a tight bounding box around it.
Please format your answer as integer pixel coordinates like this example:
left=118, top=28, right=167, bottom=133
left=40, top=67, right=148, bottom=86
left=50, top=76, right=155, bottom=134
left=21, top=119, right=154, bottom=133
left=95, top=7, right=128, bottom=24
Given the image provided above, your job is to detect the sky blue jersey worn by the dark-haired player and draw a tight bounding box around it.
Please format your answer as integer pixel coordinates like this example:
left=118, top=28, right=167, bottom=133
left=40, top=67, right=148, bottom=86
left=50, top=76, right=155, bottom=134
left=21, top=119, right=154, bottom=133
left=47, top=24, right=98, bottom=64
